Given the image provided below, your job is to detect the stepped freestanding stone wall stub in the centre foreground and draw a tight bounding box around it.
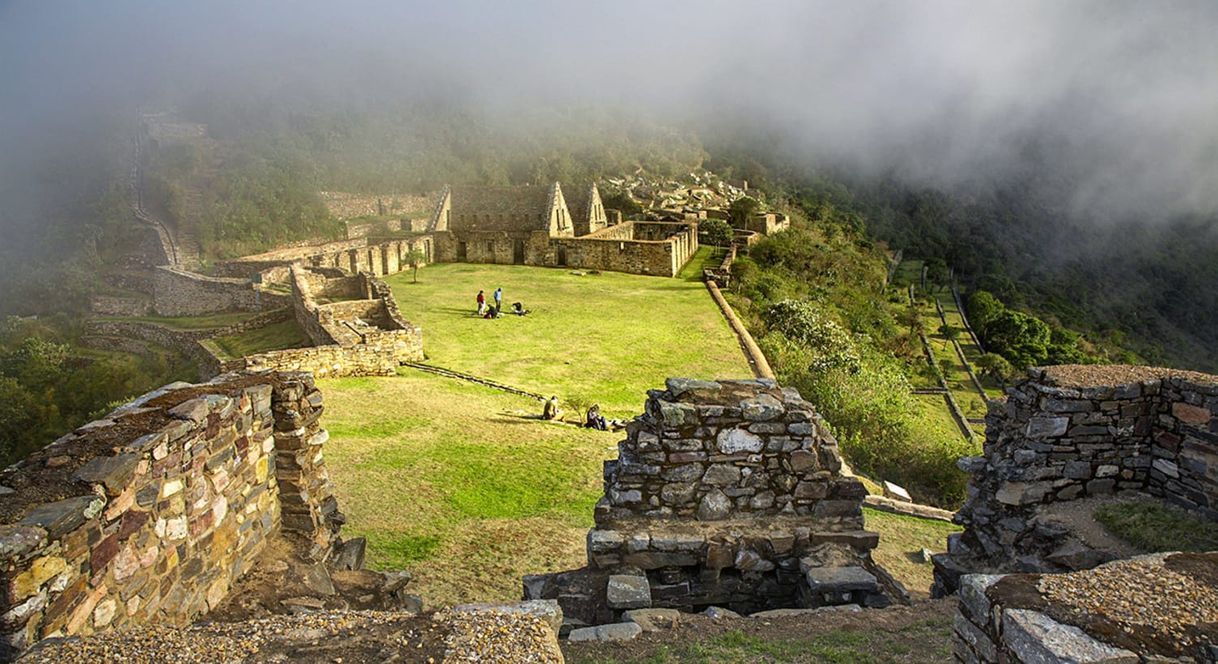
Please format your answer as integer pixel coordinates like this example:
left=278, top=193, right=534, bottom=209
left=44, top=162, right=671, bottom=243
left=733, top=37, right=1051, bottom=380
left=525, top=379, right=904, bottom=626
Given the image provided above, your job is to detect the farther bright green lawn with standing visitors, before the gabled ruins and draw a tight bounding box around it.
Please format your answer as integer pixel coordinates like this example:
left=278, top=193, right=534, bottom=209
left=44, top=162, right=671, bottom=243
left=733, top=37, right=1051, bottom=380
left=386, top=258, right=753, bottom=417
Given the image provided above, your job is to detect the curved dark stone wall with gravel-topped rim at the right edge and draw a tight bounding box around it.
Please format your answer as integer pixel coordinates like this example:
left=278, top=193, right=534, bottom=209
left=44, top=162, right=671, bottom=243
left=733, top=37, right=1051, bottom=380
left=935, top=367, right=1218, bottom=592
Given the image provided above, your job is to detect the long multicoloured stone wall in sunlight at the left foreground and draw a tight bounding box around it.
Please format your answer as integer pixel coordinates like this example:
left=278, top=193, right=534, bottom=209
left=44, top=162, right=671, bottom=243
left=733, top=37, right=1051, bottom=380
left=0, top=374, right=341, bottom=658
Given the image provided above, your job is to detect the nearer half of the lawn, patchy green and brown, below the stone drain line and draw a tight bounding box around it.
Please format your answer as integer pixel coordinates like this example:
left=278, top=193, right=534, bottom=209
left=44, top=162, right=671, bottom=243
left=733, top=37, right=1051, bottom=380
left=319, top=368, right=621, bottom=606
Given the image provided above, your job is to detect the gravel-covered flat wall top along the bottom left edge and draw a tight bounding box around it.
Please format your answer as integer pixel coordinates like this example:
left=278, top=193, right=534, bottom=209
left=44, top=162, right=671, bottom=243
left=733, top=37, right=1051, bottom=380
left=21, top=612, right=561, bottom=664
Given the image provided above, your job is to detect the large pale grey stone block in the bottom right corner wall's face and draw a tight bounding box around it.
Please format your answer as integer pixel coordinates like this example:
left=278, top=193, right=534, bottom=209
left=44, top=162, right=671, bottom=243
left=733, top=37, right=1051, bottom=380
left=1002, top=609, right=1141, bottom=664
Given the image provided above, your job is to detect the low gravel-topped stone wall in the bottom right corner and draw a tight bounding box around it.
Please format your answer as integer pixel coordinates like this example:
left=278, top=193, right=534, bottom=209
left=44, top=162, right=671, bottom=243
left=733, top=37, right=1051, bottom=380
left=952, top=553, right=1218, bottom=664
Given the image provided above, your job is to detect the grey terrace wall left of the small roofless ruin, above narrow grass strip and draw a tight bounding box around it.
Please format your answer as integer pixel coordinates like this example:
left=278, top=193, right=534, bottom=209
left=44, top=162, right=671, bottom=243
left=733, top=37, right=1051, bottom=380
left=152, top=266, right=289, bottom=316
